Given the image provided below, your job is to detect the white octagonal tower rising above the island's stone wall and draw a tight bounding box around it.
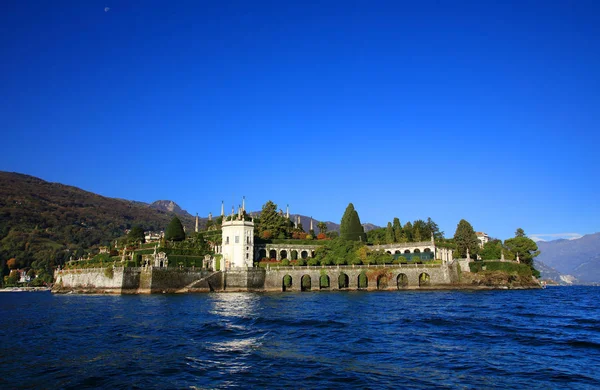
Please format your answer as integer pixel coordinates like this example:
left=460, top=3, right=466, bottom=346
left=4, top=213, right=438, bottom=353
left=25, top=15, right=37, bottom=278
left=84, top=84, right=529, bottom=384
left=219, top=203, right=254, bottom=271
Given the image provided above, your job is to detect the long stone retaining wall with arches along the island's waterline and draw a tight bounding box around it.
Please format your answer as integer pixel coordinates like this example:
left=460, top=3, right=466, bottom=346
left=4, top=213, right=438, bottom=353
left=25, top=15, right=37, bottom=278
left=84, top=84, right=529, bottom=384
left=53, top=263, right=459, bottom=294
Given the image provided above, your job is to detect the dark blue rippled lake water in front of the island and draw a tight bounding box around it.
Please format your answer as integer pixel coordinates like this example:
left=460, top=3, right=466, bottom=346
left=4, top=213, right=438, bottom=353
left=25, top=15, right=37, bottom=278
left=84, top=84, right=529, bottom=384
left=0, top=287, right=600, bottom=389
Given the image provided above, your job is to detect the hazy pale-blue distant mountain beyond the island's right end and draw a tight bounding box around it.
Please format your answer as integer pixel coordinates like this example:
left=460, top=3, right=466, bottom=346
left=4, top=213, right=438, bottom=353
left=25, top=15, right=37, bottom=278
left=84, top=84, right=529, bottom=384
left=536, top=233, right=600, bottom=283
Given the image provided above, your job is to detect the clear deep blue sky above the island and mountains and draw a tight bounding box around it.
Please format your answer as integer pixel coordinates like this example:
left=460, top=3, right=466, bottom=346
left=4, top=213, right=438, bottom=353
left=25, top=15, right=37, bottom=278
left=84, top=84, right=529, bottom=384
left=0, top=0, right=600, bottom=239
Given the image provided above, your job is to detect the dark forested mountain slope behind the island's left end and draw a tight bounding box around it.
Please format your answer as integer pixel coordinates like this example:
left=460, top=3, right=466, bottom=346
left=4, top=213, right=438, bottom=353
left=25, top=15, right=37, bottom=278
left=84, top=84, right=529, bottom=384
left=0, top=171, right=194, bottom=269
